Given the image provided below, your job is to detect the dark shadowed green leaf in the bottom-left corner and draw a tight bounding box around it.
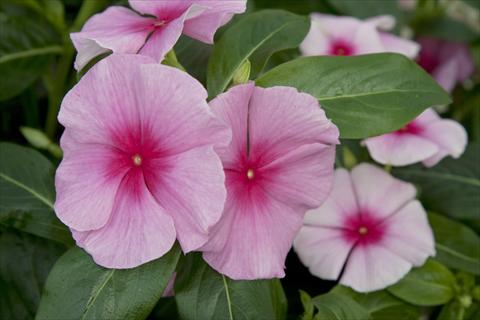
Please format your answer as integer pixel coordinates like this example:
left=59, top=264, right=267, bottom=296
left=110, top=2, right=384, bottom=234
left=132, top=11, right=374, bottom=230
left=0, top=229, right=65, bottom=320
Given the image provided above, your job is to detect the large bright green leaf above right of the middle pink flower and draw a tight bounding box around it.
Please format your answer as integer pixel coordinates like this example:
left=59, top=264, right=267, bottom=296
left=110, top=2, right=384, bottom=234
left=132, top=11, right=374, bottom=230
left=256, top=53, right=450, bottom=139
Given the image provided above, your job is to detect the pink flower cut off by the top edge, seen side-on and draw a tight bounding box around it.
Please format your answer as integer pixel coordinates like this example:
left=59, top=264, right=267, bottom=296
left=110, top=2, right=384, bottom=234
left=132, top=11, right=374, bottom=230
left=71, top=0, right=246, bottom=70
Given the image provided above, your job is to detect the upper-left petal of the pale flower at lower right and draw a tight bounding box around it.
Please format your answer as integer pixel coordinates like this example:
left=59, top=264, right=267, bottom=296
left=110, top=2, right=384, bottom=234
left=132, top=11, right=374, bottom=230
left=304, top=169, right=359, bottom=228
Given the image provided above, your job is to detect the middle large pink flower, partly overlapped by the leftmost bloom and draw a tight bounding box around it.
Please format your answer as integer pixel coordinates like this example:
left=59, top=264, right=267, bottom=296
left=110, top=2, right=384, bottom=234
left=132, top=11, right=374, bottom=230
left=198, top=83, right=339, bottom=279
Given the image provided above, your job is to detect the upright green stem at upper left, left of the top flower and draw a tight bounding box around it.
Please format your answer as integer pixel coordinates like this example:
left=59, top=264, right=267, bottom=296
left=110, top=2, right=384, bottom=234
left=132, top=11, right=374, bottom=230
left=45, top=0, right=106, bottom=140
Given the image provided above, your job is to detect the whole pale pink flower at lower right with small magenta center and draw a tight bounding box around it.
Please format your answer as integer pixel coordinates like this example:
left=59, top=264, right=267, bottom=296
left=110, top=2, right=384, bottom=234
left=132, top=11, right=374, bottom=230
left=294, top=164, right=435, bottom=292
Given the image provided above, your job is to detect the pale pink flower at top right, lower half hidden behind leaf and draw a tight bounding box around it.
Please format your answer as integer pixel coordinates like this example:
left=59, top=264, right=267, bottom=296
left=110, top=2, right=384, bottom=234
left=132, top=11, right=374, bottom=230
left=300, top=13, right=419, bottom=58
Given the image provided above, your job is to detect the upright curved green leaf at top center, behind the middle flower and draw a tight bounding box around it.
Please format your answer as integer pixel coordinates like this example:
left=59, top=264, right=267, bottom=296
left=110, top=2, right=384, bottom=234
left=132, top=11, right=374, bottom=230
left=207, top=10, right=310, bottom=98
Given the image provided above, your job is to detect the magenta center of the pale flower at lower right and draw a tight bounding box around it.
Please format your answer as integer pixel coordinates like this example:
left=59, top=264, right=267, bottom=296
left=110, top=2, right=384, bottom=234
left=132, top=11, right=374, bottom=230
left=343, top=211, right=386, bottom=245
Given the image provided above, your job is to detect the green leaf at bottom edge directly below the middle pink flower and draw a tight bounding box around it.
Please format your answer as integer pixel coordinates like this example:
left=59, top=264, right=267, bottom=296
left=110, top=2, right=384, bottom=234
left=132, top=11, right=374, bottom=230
left=175, top=254, right=287, bottom=320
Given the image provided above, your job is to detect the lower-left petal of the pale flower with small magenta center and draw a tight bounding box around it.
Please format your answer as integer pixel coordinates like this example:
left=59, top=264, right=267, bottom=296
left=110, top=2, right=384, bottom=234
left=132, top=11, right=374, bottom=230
left=293, top=225, right=354, bottom=280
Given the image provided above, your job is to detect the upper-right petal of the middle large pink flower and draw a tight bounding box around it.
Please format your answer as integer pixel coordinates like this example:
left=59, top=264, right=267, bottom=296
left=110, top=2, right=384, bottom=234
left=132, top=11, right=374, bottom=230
left=249, top=87, right=339, bottom=162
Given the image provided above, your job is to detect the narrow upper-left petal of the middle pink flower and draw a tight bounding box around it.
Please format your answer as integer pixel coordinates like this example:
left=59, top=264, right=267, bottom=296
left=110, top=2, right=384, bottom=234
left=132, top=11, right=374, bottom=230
left=210, top=82, right=255, bottom=169
